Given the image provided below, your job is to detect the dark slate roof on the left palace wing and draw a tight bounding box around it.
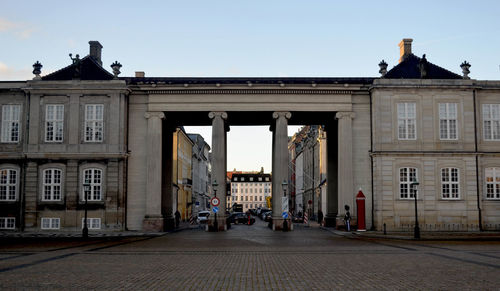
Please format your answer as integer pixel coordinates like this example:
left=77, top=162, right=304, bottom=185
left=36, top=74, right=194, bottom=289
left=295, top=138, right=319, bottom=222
left=42, top=56, right=114, bottom=81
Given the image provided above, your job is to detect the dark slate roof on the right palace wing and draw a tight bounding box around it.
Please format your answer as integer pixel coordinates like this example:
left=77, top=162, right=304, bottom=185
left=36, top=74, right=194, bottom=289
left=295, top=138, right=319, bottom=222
left=384, top=54, right=462, bottom=79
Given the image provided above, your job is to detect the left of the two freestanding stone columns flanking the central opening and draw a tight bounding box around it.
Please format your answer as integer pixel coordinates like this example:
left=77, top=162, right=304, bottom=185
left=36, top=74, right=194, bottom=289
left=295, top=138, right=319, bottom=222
left=208, top=111, right=227, bottom=230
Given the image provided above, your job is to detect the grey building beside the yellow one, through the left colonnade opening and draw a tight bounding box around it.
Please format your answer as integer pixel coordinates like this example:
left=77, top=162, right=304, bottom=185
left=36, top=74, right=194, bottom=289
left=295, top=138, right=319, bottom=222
left=188, top=133, right=210, bottom=216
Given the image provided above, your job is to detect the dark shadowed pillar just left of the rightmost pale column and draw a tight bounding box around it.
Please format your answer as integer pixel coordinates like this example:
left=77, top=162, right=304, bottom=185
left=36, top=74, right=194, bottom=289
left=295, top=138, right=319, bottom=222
left=325, top=121, right=339, bottom=227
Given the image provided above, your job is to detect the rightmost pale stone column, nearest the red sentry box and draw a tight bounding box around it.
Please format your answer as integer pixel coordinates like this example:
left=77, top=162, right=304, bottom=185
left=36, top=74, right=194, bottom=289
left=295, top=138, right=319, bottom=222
left=335, top=112, right=355, bottom=224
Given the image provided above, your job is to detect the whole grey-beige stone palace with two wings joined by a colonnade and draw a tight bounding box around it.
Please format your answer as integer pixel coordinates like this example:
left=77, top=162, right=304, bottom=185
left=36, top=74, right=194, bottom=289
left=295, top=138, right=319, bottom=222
left=0, top=39, right=500, bottom=231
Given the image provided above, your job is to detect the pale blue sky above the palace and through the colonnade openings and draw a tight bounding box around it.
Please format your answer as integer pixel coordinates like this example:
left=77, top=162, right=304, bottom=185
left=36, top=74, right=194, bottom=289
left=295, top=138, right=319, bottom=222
left=0, top=0, right=500, bottom=172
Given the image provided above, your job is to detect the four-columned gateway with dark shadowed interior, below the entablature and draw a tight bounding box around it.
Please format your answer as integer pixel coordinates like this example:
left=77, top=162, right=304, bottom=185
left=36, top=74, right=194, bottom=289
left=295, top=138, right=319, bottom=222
left=139, top=111, right=353, bottom=230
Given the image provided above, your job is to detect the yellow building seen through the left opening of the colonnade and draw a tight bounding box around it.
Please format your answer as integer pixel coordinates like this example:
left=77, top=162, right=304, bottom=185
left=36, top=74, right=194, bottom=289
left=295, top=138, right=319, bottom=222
left=172, top=128, right=193, bottom=221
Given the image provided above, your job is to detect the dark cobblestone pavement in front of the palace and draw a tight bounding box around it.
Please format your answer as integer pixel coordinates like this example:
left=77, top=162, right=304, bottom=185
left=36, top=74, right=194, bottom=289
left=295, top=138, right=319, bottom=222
left=0, top=220, right=500, bottom=290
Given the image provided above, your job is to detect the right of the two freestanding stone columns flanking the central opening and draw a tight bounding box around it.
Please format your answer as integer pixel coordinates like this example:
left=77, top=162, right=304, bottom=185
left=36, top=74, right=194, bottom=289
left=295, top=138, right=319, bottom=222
left=272, top=112, right=292, bottom=230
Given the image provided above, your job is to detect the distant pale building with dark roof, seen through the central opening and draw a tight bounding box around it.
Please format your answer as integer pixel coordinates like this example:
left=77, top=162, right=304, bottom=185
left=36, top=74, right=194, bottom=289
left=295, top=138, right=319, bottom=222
left=226, top=169, right=272, bottom=211
